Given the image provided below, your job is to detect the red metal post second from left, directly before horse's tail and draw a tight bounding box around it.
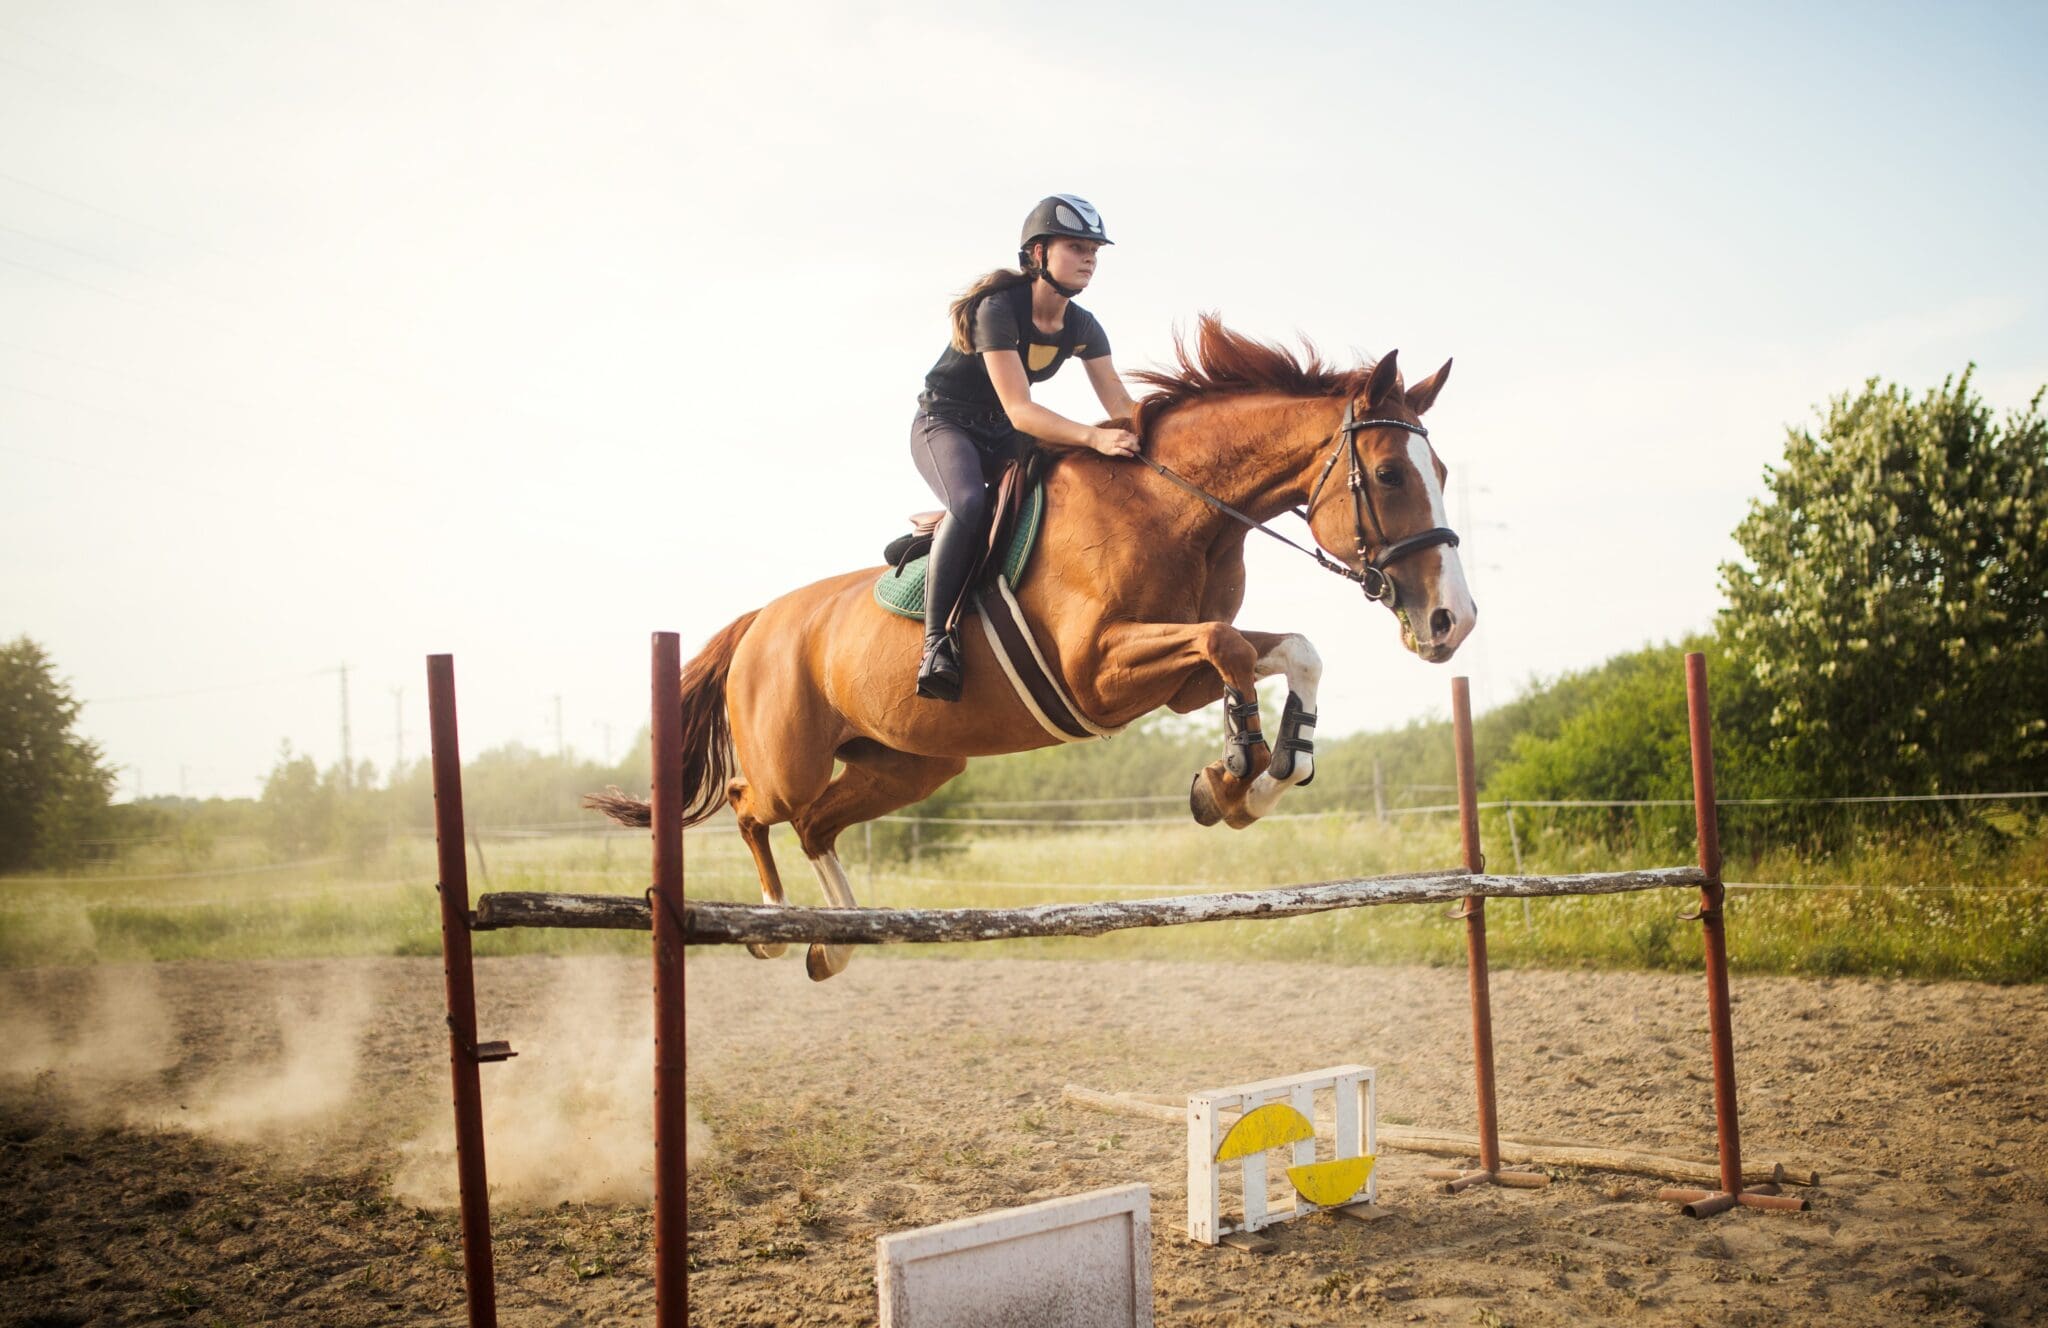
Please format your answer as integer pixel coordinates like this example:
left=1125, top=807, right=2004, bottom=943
left=651, top=631, right=690, bottom=1328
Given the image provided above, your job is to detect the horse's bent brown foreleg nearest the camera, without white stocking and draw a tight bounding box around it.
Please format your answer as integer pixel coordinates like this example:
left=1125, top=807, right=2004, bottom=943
left=1075, top=623, right=1272, bottom=830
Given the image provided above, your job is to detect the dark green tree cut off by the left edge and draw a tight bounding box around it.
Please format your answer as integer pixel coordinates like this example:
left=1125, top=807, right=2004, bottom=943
left=0, top=637, right=115, bottom=871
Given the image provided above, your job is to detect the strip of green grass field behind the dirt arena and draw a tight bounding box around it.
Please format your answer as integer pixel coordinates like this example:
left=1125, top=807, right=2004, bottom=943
left=0, top=816, right=2048, bottom=982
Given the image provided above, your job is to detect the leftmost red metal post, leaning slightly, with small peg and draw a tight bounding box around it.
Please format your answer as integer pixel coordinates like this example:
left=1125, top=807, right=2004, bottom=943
left=426, top=656, right=498, bottom=1328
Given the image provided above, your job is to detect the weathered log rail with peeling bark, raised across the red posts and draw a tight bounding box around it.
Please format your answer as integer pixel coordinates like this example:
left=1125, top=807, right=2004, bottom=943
left=475, top=867, right=1706, bottom=945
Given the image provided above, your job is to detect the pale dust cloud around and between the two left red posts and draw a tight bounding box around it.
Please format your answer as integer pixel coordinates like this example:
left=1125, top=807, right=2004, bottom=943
left=391, top=959, right=713, bottom=1207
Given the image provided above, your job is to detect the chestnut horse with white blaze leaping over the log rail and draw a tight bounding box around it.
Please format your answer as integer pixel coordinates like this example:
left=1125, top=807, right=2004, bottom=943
left=586, top=316, right=1477, bottom=982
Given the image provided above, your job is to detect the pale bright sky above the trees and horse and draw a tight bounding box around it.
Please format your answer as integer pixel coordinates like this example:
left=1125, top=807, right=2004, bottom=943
left=0, top=0, right=2048, bottom=797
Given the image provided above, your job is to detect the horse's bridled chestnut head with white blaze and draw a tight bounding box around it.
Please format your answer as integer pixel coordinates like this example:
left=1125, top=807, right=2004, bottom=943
left=1309, top=350, right=1479, bottom=664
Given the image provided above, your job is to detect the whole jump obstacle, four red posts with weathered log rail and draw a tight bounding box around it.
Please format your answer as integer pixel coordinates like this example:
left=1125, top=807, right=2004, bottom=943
left=428, top=631, right=1806, bottom=1328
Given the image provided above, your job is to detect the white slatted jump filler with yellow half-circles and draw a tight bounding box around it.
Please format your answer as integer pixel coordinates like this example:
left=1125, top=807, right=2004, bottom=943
left=1188, top=1066, right=1378, bottom=1244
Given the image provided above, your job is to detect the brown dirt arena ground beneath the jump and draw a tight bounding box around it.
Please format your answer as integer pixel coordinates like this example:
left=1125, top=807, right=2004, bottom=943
left=0, top=955, right=2048, bottom=1326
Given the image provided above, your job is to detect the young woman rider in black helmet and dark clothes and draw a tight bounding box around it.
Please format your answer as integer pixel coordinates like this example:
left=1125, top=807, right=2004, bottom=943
left=909, top=195, right=1139, bottom=701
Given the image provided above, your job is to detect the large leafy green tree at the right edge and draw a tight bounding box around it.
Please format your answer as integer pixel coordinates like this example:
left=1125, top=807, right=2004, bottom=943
left=1720, top=371, right=2048, bottom=793
